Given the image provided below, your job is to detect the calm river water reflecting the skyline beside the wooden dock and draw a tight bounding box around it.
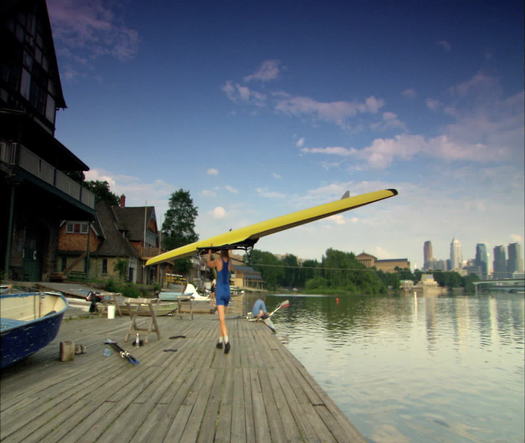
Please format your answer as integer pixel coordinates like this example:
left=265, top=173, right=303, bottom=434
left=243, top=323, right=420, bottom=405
left=260, top=293, right=525, bottom=442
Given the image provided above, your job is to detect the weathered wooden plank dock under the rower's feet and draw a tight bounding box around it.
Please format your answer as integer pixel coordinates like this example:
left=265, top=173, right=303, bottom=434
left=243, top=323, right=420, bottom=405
left=0, top=315, right=365, bottom=442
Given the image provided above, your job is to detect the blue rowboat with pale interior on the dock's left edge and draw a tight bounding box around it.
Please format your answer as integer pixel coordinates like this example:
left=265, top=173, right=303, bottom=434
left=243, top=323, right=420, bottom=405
left=0, top=292, right=67, bottom=368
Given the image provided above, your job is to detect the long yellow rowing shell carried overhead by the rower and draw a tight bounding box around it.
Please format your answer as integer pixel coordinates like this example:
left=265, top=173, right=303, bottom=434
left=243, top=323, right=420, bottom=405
left=146, top=189, right=397, bottom=266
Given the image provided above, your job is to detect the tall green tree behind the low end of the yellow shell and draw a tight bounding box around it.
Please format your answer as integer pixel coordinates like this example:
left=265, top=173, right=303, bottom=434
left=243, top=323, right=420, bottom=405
left=161, top=189, right=199, bottom=274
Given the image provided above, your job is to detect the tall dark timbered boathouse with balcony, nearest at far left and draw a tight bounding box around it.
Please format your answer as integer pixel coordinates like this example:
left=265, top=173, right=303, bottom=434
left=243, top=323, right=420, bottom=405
left=0, top=0, right=95, bottom=281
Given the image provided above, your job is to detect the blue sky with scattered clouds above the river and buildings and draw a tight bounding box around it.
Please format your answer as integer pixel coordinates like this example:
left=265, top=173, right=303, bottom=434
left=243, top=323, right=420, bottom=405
left=48, top=0, right=524, bottom=266
